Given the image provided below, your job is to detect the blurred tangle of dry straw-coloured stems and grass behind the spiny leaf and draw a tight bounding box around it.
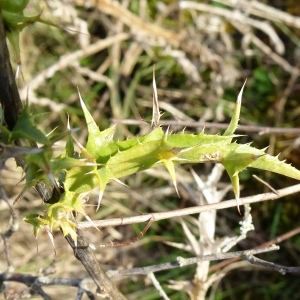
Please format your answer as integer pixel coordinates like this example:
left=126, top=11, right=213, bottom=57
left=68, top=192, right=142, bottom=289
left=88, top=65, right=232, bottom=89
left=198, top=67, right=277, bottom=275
left=0, top=0, right=300, bottom=300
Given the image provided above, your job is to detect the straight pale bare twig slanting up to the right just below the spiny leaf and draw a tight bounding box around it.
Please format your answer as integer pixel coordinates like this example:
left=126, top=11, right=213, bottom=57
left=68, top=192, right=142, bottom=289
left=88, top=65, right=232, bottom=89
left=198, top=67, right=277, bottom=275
left=78, top=184, right=300, bottom=229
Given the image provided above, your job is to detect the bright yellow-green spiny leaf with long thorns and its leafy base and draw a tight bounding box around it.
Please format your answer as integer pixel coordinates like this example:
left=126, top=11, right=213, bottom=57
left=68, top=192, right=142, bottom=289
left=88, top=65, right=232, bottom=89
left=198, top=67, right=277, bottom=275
left=2, top=77, right=300, bottom=243
